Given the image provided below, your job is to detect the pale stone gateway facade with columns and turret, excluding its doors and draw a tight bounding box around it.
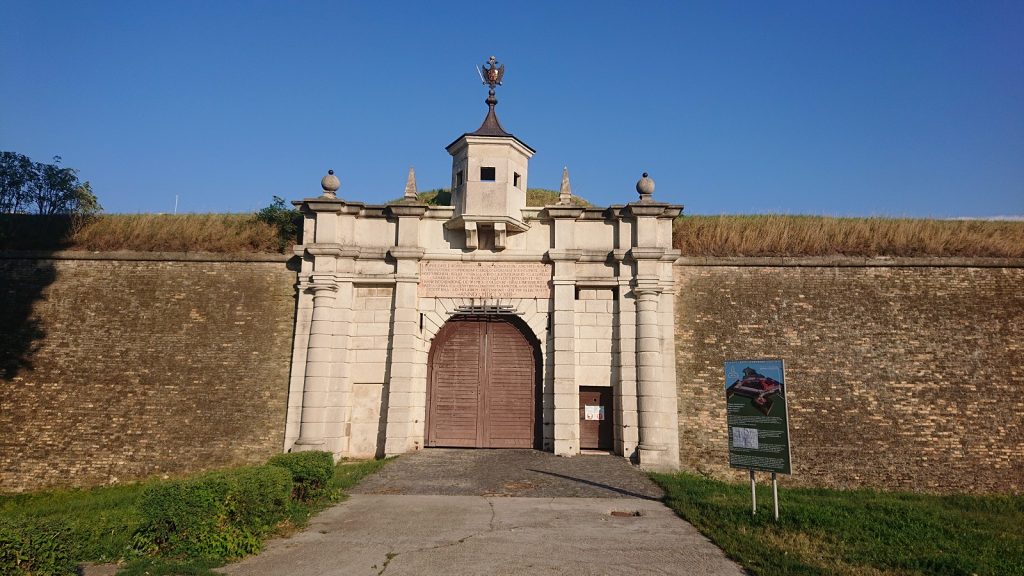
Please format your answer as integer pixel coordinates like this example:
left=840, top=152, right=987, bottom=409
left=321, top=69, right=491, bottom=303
left=285, top=96, right=680, bottom=469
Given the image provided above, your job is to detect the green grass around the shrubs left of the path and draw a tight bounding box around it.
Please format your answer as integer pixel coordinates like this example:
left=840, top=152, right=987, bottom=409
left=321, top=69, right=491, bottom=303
left=0, top=460, right=387, bottom=576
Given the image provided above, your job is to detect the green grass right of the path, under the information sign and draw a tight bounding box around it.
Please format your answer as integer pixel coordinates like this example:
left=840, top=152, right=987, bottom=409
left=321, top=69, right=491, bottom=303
left=652, top=474, right=1024, bottom=576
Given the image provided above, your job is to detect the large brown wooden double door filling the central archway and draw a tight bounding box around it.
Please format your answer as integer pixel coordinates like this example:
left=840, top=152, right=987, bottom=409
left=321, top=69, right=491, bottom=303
left=426, top=316, right=540, bottom=448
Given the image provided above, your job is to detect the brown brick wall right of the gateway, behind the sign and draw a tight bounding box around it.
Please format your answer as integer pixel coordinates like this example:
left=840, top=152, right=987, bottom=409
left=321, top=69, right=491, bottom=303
left=675, top=258, right=1024, bottom=492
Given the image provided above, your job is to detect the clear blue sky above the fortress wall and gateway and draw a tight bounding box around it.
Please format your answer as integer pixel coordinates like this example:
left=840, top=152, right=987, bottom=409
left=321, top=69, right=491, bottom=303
left=0, top=0, right=1024, bottom=217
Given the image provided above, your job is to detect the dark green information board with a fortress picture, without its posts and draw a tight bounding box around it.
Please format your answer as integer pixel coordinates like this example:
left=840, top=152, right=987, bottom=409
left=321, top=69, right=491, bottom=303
left=725, top=360, right=790, bottom=474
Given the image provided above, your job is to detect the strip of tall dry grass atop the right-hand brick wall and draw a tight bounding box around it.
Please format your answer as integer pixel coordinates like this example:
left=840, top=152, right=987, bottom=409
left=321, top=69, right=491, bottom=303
left=673, top=214, right=1024, bottom=258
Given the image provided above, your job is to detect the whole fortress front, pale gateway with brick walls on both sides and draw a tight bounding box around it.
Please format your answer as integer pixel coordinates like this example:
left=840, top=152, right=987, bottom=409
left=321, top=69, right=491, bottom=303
left=0, top=58, right=1024, bottom=493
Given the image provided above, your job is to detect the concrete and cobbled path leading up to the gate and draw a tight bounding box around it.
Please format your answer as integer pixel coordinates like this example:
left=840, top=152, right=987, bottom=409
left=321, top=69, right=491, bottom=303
left=221, top=450, right=744, bottom=576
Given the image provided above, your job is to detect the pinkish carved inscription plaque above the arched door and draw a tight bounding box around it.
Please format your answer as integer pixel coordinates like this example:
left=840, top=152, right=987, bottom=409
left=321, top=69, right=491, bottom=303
left=420, top=260, right=551, bottom=298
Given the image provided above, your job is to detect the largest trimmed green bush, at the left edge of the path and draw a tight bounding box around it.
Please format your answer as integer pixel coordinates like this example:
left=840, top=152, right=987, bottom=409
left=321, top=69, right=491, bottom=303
left=134, top=465, right=292, bottom=559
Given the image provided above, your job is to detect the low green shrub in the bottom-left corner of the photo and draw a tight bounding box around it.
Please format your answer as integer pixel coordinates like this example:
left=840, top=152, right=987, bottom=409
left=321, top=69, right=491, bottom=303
left=0, top=518, right=75, bottom=576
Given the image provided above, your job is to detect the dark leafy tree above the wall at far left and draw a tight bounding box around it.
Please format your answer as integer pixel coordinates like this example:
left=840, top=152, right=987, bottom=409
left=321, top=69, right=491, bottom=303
left=0, top=152, right=102, bottom=216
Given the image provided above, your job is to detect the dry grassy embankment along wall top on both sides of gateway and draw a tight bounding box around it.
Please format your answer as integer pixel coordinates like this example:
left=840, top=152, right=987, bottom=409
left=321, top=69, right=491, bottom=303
left=0, top=199, right=1024, bottom=258
